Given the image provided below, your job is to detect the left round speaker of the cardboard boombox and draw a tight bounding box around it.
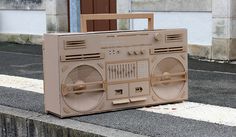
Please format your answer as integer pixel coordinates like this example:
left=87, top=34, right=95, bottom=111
left=64, top=65, right=104, bottom=112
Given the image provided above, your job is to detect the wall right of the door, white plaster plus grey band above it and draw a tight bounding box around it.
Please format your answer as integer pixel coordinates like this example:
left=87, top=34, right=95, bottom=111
left=131, top=0, right=212, bottom=46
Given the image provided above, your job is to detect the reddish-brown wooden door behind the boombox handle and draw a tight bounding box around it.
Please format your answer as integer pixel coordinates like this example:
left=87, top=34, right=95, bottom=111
left=80, top=0, right=117, bottom=31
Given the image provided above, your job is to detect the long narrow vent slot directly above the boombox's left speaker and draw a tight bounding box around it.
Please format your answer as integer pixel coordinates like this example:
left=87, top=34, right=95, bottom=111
left=61, top=53, right=105, bottom=61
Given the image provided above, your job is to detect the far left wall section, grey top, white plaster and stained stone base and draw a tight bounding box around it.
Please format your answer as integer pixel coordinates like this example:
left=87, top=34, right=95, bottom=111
left=0, top=0, right=46, bottom=44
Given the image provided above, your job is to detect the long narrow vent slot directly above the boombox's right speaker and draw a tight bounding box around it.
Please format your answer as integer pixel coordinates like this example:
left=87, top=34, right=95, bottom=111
left=151, top=47, right=184, bottom=54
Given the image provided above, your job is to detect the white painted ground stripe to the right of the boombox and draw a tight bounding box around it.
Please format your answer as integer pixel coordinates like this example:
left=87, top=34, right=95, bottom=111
left=139, top=102, right=236, bottom=127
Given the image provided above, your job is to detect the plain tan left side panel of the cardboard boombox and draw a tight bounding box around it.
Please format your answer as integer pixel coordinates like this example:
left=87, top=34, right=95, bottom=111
left=43, top=35, right=60, bottom=115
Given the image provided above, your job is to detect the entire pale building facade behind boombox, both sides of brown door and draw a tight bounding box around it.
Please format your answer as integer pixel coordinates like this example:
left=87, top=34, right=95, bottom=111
left=0, top=0, right=233, bottom=60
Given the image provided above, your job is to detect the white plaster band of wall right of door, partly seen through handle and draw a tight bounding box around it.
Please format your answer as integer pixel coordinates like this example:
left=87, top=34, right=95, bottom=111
left=131, top=12, right=212, bottom=45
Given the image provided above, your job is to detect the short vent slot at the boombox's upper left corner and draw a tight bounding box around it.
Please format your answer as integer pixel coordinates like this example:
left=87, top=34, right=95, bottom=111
left=64, top=40, right=86, bottom=49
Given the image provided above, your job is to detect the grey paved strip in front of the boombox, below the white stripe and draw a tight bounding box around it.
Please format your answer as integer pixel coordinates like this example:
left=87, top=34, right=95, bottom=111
left=75, top=107, right=236, bottom=137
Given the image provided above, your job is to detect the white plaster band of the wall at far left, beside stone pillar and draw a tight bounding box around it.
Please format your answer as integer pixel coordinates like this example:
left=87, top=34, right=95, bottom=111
left=0, top=10, right=46, bottom=35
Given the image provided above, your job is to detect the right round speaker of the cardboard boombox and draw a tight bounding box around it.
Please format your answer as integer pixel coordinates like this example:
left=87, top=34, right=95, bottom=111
left=151, top=57, right=185, bottom=100
